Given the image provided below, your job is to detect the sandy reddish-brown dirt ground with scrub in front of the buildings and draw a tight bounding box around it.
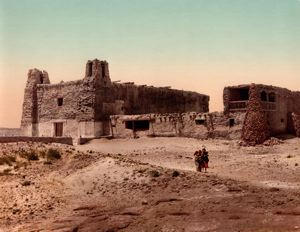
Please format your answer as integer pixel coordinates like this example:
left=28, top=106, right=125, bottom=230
left=0, top=138, right=300, bottom=232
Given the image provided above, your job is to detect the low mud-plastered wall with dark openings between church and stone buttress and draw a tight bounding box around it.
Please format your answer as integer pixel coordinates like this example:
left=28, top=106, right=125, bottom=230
left=110, top=112, right=245, bottom=139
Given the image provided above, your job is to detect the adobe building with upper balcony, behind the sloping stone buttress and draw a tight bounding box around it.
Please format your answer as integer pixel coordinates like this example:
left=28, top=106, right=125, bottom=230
left=223, top=85, right=300, bottom=136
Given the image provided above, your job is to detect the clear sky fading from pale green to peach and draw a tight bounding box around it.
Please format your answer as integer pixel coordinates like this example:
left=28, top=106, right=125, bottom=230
left=0, top=0, right=300, bottom=127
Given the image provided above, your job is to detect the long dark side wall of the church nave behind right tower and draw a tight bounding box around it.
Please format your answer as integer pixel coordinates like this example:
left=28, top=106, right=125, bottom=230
left=104, top=83, right=209, bottom=114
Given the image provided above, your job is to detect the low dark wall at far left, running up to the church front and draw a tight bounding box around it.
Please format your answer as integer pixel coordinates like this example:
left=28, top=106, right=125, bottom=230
left=0, top=136, right=73, bottom=145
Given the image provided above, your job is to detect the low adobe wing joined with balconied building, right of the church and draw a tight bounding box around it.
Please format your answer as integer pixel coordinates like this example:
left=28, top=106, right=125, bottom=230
left=110, top=84, right=300, bottom=141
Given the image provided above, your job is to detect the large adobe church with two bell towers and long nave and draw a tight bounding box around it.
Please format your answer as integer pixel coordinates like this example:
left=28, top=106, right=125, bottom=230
left=21, top=59, right=209, bottom=139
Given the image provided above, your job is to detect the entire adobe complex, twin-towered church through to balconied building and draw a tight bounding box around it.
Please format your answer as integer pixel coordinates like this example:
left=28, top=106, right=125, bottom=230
left=21, top=59, right=300, bottom=144
